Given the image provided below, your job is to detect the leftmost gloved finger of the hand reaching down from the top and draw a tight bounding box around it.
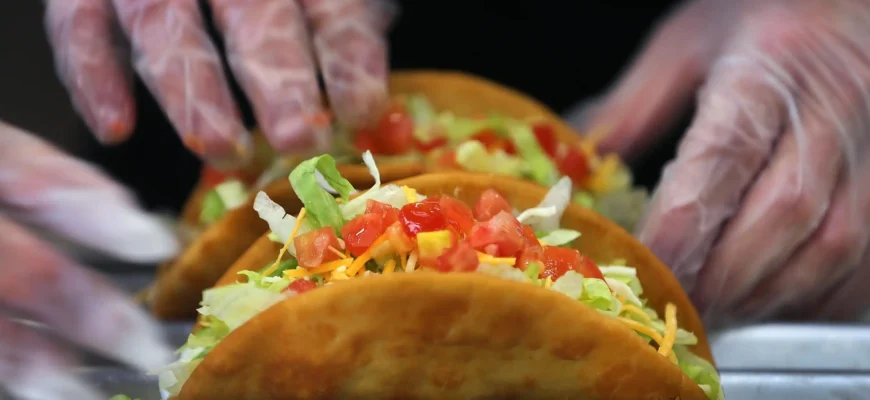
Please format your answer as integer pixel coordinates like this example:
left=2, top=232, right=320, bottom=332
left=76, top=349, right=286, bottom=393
left=45, top=0, right=136, bottom=143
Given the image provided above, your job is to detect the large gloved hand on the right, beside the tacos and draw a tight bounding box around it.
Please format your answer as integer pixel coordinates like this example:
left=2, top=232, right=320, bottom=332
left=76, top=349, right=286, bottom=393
left=572, top=0, right=870, bottom=322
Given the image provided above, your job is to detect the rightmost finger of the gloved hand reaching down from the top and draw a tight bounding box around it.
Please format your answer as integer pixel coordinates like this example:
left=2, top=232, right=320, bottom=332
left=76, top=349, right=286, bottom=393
left=302, top=0, right=389, bottom=126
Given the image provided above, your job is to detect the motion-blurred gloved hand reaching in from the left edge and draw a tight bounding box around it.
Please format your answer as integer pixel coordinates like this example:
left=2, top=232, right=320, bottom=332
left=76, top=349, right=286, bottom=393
left=0, top=122, right=178, bottom=400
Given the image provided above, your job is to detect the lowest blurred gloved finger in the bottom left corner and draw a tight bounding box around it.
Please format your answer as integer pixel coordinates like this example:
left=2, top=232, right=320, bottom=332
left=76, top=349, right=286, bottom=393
left=0, top=318, right=104, bottom=400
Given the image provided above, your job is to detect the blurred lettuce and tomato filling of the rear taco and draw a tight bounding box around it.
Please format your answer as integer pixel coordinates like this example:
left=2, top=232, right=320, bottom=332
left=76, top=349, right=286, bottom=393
left=345, top=95, right=647, bottom=229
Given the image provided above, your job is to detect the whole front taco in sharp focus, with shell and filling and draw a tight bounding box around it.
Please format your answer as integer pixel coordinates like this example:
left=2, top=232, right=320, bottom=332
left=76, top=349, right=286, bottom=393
left=158, top=152, right=724, bottom=400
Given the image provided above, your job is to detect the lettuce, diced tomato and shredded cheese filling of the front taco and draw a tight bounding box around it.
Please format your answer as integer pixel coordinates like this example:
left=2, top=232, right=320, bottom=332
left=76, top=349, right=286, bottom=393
left=159, top=152, right=724, bottom=399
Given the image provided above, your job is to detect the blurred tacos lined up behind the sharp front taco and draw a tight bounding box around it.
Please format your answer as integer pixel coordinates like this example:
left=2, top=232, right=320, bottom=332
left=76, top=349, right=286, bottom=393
left=146, top=70, right=647, bottom=319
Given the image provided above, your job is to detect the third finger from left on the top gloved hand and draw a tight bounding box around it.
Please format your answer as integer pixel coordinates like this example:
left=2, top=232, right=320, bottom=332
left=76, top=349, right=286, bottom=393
left=211, top=0, right=330, bottom=153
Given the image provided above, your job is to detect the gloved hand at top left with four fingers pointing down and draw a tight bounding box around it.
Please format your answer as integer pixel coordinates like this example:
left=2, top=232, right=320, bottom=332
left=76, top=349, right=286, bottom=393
left=46, top=0, right=392, bottom=166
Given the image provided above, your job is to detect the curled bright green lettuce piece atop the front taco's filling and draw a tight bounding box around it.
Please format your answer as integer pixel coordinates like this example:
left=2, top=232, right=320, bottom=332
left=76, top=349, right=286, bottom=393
left=290, top=155, right=354, bottom=235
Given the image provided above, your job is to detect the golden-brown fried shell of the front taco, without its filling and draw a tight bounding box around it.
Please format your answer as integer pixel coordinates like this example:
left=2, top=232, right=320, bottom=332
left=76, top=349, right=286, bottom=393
left=177, top=172, right=713, bottom=400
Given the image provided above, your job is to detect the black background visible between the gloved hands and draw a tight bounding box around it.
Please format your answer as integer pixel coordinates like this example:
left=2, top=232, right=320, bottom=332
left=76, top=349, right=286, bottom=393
left=0, top=0, right=685, bottom=216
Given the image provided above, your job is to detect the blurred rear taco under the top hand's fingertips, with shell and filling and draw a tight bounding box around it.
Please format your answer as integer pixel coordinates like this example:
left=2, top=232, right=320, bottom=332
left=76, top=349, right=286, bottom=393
left=344, top=70, right=648, bottom=230
